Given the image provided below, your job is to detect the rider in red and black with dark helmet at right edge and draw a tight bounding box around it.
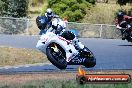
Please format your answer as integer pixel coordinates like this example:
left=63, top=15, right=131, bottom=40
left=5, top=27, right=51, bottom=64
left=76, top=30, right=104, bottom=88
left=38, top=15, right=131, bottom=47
left=116, top=11, right=132, bottom=40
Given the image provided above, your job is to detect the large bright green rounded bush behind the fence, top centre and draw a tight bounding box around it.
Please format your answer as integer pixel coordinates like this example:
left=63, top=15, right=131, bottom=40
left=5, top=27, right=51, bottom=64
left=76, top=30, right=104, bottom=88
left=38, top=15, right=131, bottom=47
left=42, top=0, right=95, bottom=21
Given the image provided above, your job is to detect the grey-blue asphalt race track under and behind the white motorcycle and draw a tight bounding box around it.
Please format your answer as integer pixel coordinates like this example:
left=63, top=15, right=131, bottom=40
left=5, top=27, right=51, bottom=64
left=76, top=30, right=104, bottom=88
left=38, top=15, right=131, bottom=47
left=0, top=35, right=132, bottom=73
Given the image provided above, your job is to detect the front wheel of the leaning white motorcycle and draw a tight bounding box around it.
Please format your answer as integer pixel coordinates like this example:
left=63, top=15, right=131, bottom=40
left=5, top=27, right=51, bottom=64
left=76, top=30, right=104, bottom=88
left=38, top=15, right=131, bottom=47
left=46, top=43, right=67, bottom=69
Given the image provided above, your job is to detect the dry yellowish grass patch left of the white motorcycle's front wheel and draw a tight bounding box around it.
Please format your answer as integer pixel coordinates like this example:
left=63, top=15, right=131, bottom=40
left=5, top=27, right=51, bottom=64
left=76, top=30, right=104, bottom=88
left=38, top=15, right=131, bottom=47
left=0, top=47, right=48, bottom=66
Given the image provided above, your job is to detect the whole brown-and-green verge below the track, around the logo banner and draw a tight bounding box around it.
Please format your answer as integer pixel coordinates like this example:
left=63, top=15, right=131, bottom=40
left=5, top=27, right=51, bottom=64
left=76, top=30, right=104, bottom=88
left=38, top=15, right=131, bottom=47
left=0, top=71, right=132, bottom=88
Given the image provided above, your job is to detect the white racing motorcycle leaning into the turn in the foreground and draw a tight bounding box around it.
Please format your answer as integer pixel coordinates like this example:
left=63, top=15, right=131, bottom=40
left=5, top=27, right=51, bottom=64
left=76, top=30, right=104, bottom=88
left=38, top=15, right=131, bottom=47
left=36, top=20, right=96, bottom=69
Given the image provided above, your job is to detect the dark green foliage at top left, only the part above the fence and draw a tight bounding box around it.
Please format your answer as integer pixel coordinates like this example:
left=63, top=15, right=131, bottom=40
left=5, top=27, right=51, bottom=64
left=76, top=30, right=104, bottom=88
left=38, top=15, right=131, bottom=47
left=1, top=0, right=28, bottom=17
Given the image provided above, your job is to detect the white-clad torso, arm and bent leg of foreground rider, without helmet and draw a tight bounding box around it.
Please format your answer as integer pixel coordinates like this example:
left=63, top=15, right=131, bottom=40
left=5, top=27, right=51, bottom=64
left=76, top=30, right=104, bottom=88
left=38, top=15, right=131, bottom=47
left=52, top=18, right=84, bottom=50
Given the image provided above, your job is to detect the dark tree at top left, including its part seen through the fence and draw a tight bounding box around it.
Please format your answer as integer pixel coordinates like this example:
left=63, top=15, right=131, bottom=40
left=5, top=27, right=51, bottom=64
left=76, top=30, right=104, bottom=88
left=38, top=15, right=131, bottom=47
left=0, top=0, right=28, bottom=34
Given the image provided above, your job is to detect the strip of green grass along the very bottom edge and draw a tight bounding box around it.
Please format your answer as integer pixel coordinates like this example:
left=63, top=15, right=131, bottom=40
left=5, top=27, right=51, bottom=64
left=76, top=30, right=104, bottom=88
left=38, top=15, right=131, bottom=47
left=0, top=79, right=132, bottom=88
